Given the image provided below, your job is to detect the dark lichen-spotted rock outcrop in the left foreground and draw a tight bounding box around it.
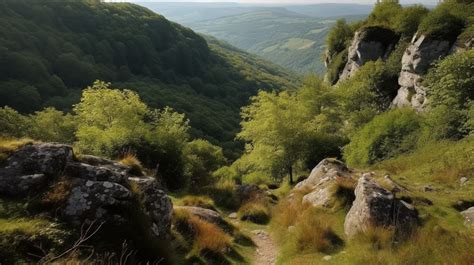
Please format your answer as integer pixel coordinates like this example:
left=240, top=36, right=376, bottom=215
left=0, top=143, right=173, bottom=238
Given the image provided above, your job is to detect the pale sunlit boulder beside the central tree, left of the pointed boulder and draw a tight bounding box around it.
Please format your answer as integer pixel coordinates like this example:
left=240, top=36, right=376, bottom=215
left=290, top=159, right=353, bottom=207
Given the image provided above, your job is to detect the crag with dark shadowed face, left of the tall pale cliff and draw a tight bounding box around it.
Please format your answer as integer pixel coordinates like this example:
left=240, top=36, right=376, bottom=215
left=339, top=27, right=399, bottom=81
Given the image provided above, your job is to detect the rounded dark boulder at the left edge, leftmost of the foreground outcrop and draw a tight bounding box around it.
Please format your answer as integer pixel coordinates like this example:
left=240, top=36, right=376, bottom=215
left=0, top=143, right=74, bottom=196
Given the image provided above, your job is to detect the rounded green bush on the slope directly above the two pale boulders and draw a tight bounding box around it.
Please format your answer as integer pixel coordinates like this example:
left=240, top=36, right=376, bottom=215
left=344, top=109, right=421, bottom=166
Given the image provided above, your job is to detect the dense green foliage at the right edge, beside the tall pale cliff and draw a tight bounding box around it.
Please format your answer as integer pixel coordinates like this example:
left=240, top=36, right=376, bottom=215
left=424, top=50, right=474, bottom=140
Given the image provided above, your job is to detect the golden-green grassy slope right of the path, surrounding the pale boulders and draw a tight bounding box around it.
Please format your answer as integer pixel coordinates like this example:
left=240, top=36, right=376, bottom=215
left=270, top=137, right=474, bottom=265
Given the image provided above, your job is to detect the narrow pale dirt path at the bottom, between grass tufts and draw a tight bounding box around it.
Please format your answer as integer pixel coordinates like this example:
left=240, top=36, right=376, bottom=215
left=250, top=230, right=277, bottom=265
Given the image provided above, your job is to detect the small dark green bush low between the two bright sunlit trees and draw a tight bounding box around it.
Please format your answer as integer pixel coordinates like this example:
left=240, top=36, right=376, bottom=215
left=183, top=139, right=226, bottom=187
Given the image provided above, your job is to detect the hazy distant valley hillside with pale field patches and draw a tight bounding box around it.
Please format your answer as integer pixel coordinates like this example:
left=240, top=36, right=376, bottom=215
left=140, top=2, right=370, bottom=75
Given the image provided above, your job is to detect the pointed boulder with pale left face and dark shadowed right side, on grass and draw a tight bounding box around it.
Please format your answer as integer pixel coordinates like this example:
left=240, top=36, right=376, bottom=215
left=344, top=174, right=418, bottom=236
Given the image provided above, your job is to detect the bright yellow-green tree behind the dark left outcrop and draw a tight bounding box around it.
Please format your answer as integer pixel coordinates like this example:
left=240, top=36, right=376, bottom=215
left=74, top=81, right=147, bottom=157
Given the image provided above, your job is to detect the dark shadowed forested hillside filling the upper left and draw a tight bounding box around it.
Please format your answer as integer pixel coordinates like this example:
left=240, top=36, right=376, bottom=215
left=0, top=1, right=294, bottom=156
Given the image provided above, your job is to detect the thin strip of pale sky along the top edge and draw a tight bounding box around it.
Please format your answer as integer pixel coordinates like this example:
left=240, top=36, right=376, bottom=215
left=106, top=0, right=438, bottom=5
